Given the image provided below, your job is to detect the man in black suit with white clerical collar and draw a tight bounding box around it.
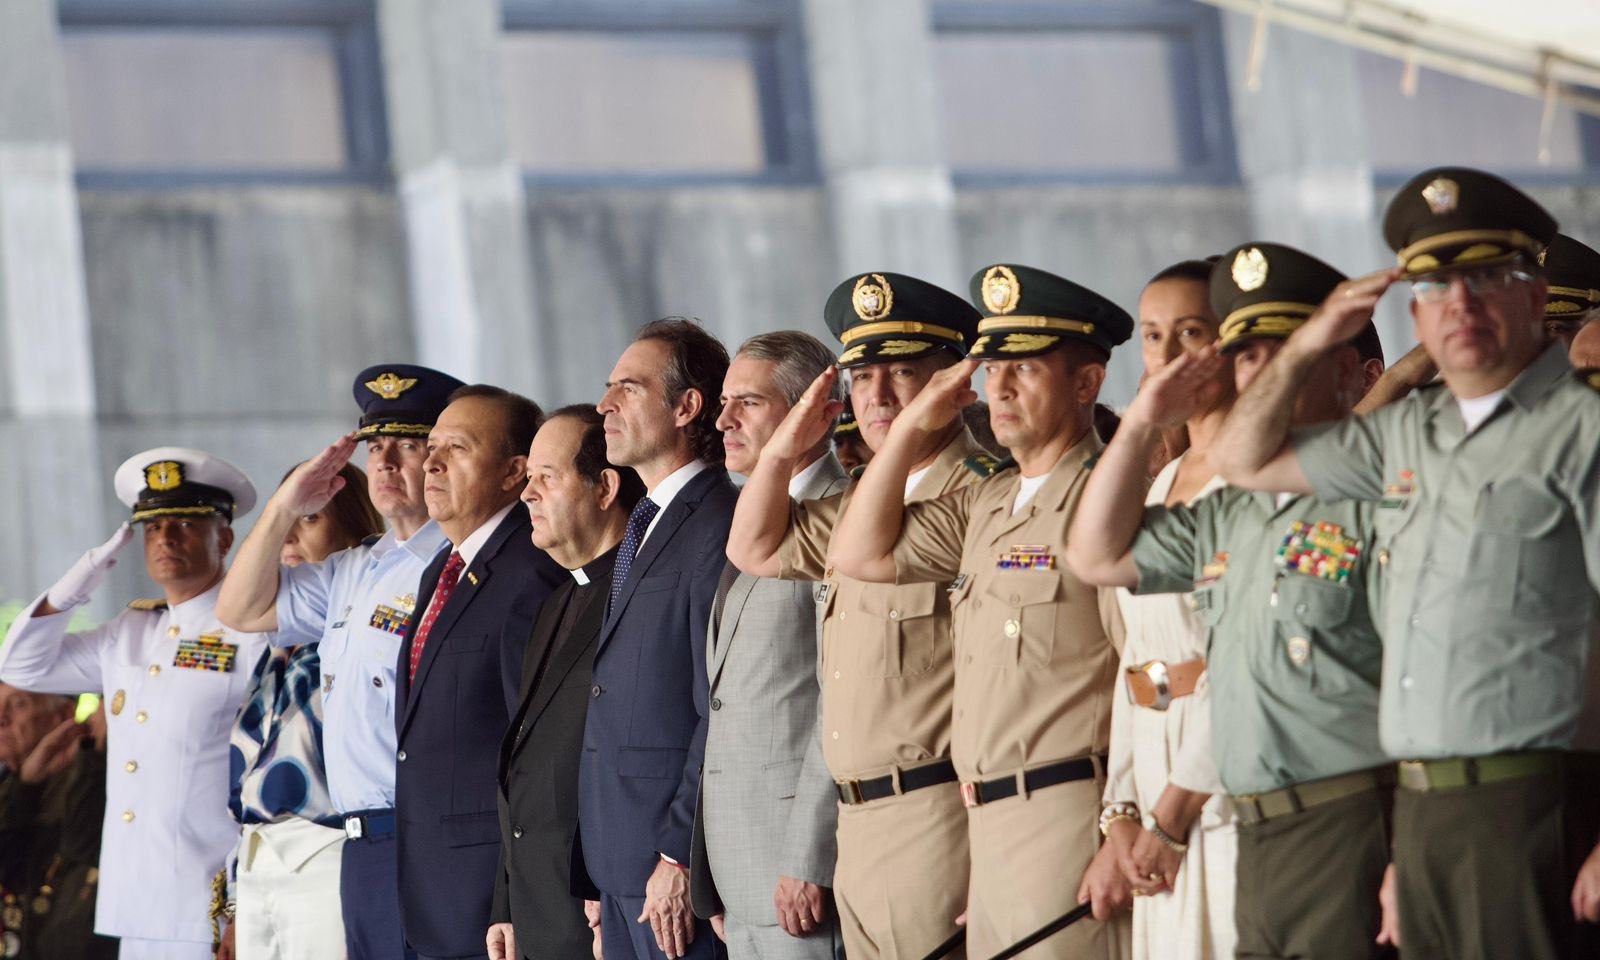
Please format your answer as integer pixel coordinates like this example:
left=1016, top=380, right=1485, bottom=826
left=486, top=405, right=645, bottom=960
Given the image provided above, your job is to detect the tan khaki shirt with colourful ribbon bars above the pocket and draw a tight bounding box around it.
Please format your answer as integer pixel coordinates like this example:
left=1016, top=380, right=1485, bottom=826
left=894, top=430, right=1123, bottom=781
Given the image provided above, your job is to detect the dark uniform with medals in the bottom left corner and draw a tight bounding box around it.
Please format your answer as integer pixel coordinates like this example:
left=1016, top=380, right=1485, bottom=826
left=0, top=746, right=117, bottom=960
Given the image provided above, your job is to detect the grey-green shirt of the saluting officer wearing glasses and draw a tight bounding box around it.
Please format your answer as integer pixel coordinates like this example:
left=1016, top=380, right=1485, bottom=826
left=1293, top=344, right=1600, bottom=758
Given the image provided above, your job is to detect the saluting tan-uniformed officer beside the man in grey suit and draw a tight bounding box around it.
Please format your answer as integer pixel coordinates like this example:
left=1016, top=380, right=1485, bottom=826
left=728, top=274, right=995, bottom=960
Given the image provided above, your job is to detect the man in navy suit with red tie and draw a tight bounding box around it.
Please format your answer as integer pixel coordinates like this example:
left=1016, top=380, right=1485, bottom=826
left=395, top=386, right=566, bottom=958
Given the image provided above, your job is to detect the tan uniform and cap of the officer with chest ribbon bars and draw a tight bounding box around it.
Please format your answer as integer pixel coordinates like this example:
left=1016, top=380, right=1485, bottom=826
left=894, top=264, right=1133, bottom=960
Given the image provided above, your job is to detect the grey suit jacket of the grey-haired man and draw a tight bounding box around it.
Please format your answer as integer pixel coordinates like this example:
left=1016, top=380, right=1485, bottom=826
left=690, top=453, right=850, bottom=925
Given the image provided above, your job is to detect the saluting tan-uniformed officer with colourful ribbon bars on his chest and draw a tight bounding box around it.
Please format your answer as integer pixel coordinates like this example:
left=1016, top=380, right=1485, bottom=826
left=830, top=264, right=1133, bottom=958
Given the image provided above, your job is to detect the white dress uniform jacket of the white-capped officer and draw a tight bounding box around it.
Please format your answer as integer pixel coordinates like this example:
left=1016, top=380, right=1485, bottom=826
left=0, top=587, right=267, bottom=942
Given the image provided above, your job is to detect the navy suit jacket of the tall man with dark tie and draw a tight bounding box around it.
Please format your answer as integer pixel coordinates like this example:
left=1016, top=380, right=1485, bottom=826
left=578, top=464, right=739, bottom=896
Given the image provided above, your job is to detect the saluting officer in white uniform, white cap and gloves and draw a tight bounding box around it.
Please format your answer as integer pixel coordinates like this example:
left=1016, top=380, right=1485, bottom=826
left=0, top=446, right=266, bottom=960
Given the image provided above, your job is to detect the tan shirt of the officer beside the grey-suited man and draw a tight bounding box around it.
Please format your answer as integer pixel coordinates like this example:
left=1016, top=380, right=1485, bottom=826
left=779, top=430, right=984, bottom=779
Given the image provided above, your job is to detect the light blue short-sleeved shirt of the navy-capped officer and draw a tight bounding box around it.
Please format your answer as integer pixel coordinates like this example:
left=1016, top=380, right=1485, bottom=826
left=272, top=520, right=445, bottom=813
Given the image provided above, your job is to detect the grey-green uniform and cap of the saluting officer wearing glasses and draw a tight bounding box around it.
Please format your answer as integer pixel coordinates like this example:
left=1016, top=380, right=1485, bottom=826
left=1293, top=170, right=1600, bottom=960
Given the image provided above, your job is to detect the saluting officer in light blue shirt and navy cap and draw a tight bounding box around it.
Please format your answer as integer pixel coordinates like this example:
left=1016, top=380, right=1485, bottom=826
left=218, top=363, right=462, bottom=960
